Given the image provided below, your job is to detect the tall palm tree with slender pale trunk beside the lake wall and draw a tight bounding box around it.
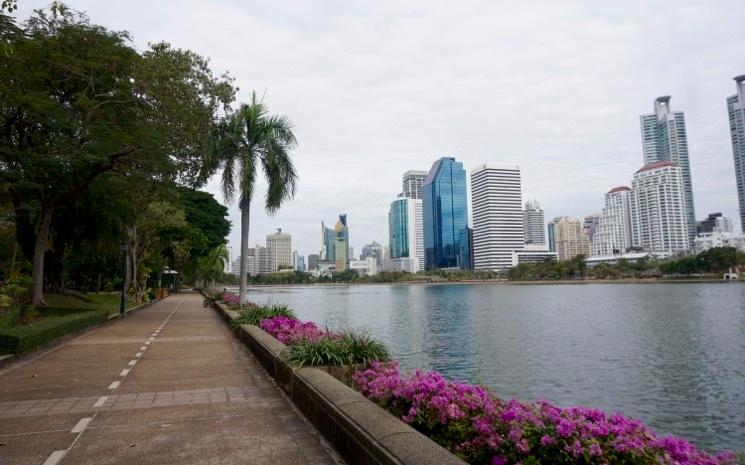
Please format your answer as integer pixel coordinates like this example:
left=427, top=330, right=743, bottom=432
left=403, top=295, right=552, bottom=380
left=217, top=92, right=297, bottom=305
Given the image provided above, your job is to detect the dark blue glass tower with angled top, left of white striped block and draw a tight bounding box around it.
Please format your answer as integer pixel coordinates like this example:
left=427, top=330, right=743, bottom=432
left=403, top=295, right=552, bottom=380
left=422, top=157, right=468, bottom=270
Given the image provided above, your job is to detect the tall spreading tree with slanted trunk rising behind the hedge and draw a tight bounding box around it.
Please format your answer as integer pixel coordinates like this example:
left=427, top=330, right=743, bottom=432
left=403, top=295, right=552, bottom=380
left=0, top=3, right=234, bottom=304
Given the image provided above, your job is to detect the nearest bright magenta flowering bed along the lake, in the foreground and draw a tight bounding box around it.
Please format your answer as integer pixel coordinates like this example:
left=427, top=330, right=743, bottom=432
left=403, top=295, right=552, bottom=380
left=352, top=362, right=736, bottom=465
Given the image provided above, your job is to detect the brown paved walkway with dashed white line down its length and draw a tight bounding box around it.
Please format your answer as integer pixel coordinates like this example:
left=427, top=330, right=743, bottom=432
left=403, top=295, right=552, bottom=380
left=0, top=293, right=336, bottom=465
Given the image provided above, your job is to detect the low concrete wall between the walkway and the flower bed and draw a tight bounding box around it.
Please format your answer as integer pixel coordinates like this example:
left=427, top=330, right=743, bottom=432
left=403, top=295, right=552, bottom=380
left=215, top=303, right=464, bottom=465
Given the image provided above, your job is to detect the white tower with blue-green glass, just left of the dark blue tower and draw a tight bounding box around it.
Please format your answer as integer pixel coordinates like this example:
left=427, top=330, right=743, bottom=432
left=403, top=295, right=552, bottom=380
left=388, top=197, right=424, bottom=273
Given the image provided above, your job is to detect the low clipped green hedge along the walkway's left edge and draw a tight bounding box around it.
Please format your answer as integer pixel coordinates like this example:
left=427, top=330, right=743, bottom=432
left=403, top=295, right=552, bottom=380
left=0, top=309, right=109, bottom=354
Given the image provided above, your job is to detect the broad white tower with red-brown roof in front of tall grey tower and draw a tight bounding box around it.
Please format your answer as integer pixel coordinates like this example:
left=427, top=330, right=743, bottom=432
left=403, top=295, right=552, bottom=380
left=631, top=161, right=691, bottom=255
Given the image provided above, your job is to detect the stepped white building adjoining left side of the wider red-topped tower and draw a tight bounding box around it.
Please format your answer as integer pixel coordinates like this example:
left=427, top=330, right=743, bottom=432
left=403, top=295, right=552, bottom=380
left=590, top=186, right=631, bottom=257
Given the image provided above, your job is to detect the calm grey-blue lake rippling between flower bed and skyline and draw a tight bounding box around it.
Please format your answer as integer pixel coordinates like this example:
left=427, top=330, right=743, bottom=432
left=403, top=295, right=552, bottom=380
left=237, top=283, right=745, bottom=451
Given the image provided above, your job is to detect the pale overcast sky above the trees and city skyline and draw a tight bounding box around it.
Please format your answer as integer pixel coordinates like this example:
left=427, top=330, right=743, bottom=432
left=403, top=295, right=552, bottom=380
left=15, top=0, right=745, bottom=255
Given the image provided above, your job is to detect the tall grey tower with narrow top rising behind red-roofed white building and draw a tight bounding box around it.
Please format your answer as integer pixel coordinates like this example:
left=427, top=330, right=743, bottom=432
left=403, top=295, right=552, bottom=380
left=639, top=96, right=696, bottom=242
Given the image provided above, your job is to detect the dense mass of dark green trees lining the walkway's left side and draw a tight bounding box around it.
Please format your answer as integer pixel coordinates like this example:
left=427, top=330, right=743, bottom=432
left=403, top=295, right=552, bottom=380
left=0, top=2, right=236, bottom=304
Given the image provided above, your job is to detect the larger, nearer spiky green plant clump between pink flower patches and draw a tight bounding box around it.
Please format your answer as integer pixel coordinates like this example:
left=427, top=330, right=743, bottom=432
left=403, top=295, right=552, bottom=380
left=289, top=331, right=391, bottom=366
